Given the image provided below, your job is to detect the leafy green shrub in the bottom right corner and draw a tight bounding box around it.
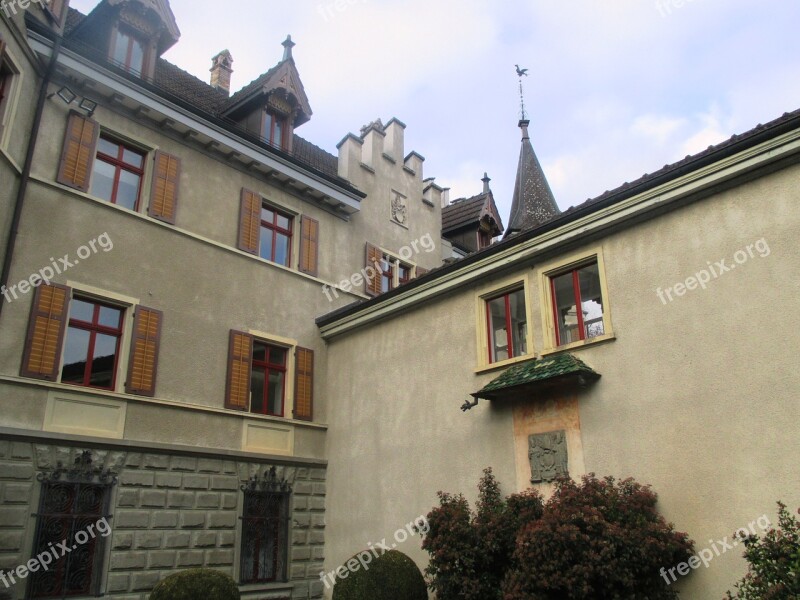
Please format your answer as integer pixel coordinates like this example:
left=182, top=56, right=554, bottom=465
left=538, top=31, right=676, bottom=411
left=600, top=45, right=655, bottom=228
left=726, top=502, right=800, bottom=600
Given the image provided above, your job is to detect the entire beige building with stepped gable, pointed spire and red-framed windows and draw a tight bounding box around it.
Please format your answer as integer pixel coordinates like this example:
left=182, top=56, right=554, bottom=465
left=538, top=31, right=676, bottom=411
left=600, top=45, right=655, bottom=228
left=0, top=0, right=800, bottom=600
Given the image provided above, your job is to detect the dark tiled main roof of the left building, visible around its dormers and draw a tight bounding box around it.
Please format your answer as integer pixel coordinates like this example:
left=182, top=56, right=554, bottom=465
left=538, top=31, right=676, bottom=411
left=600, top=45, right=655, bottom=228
left=59, top=8, right=341, bottom=180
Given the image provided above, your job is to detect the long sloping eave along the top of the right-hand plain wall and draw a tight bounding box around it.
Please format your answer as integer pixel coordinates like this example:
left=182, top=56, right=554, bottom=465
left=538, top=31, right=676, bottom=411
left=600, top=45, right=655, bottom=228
left=316, top=115, right=800, bottom=340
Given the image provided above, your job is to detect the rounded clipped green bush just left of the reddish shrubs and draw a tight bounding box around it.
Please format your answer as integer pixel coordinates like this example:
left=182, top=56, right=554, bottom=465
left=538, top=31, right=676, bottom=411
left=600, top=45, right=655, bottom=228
left=333, top=550, right=428, bottom=600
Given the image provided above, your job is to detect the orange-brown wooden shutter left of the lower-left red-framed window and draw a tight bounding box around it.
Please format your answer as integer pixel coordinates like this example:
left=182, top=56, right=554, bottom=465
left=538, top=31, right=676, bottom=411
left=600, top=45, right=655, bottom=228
left=20, top=283, right=71, bottom=381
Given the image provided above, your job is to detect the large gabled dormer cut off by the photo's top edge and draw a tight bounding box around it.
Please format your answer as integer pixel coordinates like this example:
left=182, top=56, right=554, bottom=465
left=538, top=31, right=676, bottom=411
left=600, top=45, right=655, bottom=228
left=71, top=0, right=181, bottom=80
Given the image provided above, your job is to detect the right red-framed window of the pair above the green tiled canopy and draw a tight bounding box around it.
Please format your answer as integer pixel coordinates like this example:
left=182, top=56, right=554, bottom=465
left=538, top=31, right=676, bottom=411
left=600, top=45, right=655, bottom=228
left=550, top=261, right=605, bottom=346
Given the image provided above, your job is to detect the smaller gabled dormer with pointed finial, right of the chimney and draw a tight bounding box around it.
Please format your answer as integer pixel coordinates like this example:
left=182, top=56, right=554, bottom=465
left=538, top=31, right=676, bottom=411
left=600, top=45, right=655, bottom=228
left=223, top=36, right=312, bottom=151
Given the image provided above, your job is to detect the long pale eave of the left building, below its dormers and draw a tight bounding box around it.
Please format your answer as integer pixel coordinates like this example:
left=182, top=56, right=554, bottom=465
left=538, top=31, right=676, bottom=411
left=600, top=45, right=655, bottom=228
left=28, top=29, right=366, bottom=220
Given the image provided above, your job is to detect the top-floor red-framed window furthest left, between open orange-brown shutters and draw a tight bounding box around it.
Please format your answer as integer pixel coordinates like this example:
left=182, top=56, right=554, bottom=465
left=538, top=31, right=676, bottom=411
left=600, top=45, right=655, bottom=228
left=91, top=136, right=144, bottom=211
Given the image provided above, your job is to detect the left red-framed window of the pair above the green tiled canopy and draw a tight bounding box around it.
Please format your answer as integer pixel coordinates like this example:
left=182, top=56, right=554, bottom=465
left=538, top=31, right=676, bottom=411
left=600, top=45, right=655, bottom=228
left=486, top=289, right=528, bottom=363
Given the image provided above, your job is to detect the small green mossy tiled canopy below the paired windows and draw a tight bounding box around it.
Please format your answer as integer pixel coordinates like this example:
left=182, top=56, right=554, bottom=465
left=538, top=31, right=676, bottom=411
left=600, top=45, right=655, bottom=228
left=473, top=354, right=600, bottom=400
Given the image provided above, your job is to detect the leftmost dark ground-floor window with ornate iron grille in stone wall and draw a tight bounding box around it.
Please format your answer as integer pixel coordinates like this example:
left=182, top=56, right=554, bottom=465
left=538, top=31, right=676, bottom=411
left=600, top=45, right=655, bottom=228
left=26, top=451, right=114, bottom=598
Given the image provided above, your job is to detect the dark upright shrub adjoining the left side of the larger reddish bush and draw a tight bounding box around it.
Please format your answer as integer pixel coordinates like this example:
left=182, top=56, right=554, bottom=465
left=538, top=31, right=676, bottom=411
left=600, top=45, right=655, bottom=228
left=422, top=469, right=543, bottom=600
